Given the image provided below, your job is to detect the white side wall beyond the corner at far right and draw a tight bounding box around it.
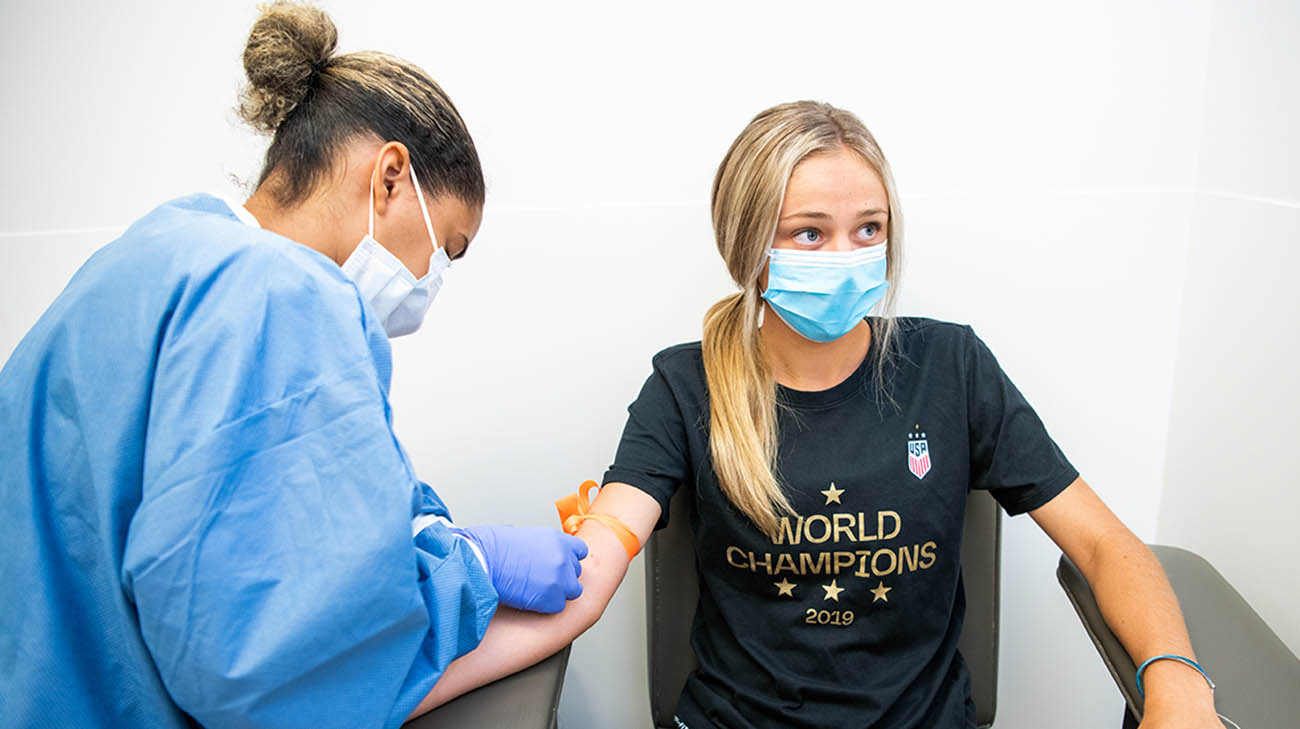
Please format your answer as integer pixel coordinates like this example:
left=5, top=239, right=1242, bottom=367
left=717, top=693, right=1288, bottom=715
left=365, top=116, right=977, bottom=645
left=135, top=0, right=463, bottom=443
left=1158, top=0, right=1300, bottom=654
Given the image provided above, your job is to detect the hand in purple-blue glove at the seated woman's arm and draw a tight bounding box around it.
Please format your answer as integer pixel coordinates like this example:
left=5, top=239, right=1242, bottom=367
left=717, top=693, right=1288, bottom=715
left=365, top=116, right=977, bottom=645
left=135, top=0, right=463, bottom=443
left=452, top=526, right=586, bottom=612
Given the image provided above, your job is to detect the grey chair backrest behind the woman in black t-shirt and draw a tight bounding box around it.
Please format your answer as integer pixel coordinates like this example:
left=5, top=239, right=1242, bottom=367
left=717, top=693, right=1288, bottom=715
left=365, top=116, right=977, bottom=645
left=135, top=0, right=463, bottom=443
left=645, top=489, right=1002, bottom=729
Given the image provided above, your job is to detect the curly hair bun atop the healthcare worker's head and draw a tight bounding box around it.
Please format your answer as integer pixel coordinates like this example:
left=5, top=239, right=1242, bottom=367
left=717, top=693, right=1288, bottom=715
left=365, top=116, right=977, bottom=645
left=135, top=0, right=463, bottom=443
left=239, top=3, right=338, bottom=133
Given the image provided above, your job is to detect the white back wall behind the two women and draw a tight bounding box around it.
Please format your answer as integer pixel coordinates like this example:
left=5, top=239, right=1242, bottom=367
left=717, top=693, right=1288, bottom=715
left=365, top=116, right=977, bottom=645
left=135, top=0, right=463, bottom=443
left=0, top=0, right=1258, bottom=729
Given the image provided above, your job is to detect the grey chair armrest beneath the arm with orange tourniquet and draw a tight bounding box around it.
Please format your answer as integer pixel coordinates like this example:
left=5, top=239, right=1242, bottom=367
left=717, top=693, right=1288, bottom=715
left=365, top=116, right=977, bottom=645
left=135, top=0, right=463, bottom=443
left=403, top=646, right=572, bottom=729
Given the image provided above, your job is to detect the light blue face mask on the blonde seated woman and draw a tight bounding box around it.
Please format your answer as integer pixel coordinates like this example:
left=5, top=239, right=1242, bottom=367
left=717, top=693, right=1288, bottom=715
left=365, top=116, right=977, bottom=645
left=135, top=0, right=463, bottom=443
left=763, top=242, right=889, bottom=342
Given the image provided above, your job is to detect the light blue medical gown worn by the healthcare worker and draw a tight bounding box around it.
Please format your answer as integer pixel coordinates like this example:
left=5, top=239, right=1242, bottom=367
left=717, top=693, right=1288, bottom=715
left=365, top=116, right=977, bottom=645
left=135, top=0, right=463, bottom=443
left=0, top=195, right=497, bottom=728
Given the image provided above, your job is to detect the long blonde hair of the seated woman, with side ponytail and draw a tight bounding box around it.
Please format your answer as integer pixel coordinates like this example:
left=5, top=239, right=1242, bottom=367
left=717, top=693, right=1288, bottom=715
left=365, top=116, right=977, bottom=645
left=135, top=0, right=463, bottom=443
left=702, top=101, right=902, bottom=538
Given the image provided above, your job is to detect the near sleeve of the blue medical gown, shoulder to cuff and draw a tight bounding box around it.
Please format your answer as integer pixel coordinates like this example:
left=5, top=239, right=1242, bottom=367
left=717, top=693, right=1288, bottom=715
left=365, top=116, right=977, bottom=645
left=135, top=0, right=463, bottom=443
left=122, top=242, right=497, bottom=728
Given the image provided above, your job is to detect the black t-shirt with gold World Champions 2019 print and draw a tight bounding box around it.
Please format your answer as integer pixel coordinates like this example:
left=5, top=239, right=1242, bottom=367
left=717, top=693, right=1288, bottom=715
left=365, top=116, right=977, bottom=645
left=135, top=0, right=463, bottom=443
left=605, top=318, right=1078, bottom=729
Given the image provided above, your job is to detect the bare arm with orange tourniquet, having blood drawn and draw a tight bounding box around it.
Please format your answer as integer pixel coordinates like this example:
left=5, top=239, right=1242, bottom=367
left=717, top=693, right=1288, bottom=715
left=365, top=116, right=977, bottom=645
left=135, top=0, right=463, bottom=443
left=408, top=483, right=660, bottom=719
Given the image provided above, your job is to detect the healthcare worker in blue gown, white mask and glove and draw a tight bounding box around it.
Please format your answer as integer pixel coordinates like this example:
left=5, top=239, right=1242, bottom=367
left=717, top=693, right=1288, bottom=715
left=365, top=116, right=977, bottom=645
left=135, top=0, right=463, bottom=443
left=0, top=4, right=586, bottom=728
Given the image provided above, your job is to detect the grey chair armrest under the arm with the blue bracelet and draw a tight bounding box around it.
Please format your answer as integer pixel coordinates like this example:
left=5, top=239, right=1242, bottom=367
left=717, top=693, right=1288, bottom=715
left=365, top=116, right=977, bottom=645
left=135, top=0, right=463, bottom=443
left=1057, top=544, right=1300, bottom=728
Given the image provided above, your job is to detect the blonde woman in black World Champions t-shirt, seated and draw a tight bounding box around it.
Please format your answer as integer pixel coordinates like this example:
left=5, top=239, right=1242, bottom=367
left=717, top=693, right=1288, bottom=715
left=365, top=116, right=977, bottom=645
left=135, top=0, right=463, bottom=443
left=428, top=101, right=1221, bottom=729
